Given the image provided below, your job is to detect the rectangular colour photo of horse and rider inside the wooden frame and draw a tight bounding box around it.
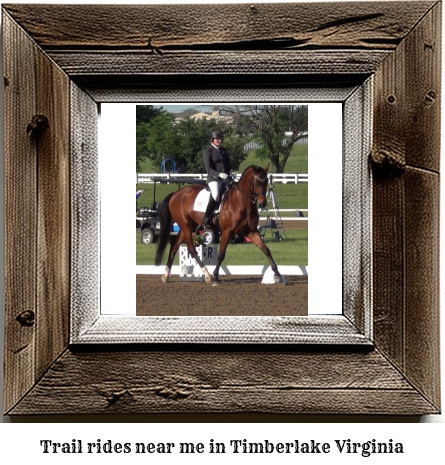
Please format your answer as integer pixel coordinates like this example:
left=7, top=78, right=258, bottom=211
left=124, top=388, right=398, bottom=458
left=136, top=103, right=308, bottom=316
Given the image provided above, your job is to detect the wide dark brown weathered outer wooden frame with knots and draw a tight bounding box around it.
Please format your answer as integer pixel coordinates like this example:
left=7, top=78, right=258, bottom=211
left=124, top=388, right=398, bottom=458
left=2, top=2, right=441, bottom=415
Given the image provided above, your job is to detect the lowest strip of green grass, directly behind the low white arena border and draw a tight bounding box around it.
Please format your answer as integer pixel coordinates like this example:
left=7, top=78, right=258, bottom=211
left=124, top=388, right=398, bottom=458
left=136, top=229, right=308, bottom=266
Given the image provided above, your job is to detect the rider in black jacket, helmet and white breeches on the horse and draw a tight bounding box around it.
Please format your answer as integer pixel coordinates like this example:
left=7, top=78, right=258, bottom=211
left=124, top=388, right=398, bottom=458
left=202, top=129, right=232, bottom=227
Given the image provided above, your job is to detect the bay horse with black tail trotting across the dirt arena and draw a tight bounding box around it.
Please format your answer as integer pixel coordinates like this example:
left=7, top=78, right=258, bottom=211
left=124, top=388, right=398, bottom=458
left=155, top=165, right=286, bottom=285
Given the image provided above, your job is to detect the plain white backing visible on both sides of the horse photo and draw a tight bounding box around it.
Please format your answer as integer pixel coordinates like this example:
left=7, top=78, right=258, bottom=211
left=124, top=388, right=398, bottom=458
left=99, top=102, right=343, bottom=315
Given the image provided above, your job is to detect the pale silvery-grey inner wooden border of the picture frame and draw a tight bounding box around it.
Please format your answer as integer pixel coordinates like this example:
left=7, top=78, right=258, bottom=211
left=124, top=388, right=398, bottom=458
left=70, top=82, right=373, bottom=345
